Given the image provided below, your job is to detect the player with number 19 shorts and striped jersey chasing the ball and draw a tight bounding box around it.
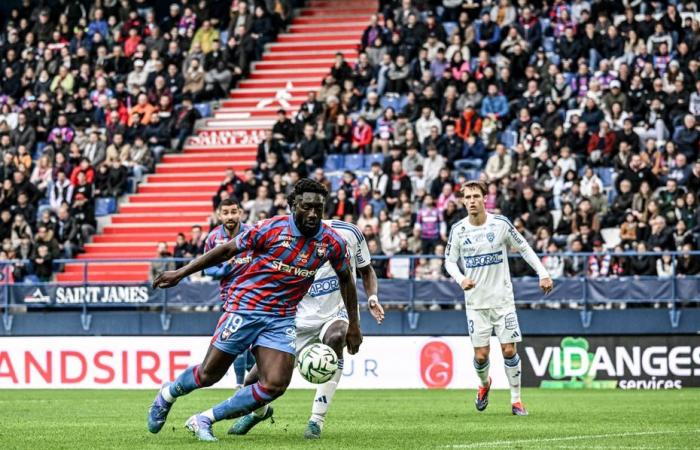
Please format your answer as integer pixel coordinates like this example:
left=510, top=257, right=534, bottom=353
left=148, top=179, right=362, bottom=441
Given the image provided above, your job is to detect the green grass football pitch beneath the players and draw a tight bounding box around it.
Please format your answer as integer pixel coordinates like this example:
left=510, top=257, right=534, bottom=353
left=0, top=389, right=700, bottom=450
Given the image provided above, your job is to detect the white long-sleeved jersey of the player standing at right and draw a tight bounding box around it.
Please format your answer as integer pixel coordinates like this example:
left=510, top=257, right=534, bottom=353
left=445, top=213, right=549, bottom=309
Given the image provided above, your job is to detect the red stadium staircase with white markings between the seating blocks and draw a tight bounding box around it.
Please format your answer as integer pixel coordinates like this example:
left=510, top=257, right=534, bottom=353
left=56, top=0, right=377, bottom=282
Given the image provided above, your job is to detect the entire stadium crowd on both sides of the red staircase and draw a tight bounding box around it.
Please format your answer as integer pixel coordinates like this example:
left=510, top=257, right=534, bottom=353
left=0, top=0, right=700, bottom=286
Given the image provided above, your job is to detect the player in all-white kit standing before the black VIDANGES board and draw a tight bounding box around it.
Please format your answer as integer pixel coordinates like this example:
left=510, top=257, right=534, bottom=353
left=445, top=181, right=553, bottom=416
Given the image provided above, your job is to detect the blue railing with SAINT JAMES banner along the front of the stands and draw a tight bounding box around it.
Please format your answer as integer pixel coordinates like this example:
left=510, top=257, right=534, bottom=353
left=0, top=251, right=700, bottom=329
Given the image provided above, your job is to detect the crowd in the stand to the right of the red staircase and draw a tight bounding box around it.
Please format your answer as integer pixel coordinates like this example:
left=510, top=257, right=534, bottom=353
left=206, top=0, right=700, bottom=279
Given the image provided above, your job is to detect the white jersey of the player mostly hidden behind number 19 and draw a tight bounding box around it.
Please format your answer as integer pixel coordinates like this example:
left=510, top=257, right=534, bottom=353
left=296, top=220, right=371, bottom=326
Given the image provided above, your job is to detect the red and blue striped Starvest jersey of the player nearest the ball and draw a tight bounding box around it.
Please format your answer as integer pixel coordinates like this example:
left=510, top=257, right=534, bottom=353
left=224, top=215, right=350, bottom=316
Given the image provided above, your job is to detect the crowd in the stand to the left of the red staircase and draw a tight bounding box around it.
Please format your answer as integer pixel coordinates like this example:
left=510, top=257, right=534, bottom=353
left=0, top=0, right=292, bottom=281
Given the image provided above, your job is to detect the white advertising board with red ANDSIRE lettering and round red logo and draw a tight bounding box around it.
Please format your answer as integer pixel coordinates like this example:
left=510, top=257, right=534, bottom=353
left=0, top=336, right=508, bottom=389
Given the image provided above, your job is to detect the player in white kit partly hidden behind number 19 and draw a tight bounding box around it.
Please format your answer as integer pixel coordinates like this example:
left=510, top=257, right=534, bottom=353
left=229, top=220, right=384, bottom=439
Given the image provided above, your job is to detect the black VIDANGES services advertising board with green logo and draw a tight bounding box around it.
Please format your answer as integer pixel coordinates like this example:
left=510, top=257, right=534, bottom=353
left=519, top=336, right=700, bottom=389
